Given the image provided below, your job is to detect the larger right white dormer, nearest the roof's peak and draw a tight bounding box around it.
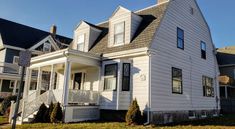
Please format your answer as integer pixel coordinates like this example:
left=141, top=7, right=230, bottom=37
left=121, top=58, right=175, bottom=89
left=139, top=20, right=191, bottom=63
left=108, top=6, right=142, bottom=47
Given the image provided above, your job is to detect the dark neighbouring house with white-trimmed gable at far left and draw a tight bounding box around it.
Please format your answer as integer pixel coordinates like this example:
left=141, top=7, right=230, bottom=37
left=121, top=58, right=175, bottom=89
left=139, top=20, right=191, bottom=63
left=0, top=18, right=72, bottom=99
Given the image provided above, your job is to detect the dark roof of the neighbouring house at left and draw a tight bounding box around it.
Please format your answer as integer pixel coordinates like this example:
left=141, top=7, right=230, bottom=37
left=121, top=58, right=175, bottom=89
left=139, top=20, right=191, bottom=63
left=0, top=18, right=72, bottom=49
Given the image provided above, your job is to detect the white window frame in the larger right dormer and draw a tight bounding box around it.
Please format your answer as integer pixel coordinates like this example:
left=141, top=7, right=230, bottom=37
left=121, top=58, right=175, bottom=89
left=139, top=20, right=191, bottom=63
left=113, top=21, right=125, bottom=46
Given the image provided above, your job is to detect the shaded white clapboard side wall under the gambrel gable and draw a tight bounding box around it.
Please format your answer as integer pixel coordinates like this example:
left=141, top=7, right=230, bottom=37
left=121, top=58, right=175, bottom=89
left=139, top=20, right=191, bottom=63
left=151, top=0, right=219, bottom=112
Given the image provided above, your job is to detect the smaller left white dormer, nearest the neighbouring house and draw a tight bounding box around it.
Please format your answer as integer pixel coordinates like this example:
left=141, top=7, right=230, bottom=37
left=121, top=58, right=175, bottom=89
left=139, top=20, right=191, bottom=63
left=72, top=21, right=101, bottom=52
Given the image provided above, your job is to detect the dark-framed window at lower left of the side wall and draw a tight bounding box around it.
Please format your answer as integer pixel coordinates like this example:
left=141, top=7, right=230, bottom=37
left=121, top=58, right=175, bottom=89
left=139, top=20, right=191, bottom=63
left=172, top=68, right=183, bottom=94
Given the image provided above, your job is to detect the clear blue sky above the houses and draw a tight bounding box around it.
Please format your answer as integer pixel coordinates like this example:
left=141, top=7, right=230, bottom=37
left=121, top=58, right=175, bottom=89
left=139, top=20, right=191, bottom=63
left=0, top=0, right=235, bottom=47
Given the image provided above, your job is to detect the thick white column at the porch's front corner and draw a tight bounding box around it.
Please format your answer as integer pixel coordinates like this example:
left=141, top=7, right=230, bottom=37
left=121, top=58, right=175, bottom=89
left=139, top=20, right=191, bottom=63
left=62, top=61, right=71, bottom=106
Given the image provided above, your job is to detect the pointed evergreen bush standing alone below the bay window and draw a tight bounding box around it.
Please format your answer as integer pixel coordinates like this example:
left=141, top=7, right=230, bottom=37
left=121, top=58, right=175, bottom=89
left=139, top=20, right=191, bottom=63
left=126, top=99, right=142, bottom=125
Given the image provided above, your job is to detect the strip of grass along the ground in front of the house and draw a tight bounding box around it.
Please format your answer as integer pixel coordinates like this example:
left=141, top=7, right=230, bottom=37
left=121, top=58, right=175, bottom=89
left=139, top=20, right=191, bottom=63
left=2, top=115, right=235, bottom=129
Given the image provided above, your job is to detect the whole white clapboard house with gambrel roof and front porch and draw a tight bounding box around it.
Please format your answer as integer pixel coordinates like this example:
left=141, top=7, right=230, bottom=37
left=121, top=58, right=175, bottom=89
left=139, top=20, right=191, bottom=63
left=12, top=0, right=220, bottom=123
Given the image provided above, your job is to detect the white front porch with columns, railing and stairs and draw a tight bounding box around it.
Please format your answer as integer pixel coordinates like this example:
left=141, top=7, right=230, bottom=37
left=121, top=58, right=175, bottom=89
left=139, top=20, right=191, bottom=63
left=12, top=49, right=100, bottom=122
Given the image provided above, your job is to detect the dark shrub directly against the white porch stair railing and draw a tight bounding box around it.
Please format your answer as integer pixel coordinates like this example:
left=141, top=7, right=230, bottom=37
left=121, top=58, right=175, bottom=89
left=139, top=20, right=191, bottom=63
left=33, top=103, right=47, bottom=123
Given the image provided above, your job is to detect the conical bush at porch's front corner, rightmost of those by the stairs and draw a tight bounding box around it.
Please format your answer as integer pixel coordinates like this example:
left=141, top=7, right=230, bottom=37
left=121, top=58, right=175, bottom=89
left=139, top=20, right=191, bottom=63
left=50, top=102, right=63, bottom=123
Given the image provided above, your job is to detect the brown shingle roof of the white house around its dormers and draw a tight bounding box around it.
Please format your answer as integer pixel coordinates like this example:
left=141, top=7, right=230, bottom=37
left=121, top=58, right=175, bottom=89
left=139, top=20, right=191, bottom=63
left=90, top=2, right=168, bottom=54
